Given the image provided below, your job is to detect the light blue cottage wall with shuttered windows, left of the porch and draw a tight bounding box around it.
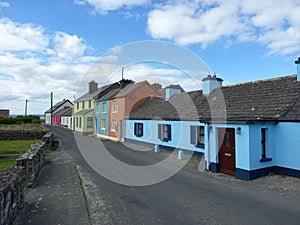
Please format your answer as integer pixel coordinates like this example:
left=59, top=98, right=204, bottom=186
left=125, top=119, right=204, bottom=153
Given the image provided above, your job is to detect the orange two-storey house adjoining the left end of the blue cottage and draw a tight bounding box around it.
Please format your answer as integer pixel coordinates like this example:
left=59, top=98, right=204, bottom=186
left=109, top=81, right=161, bottom=140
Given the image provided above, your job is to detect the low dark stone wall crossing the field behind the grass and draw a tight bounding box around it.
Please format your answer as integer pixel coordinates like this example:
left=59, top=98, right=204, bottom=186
left=0, top=130, right=48, bottom=140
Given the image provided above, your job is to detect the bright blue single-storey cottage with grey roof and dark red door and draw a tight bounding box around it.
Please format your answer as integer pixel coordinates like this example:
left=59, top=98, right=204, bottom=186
left=125, top=69, right=300, bottom=180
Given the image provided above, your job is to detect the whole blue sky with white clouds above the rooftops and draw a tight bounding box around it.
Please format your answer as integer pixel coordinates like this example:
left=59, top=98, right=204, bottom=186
left=0, top=0, right=300, bottom=115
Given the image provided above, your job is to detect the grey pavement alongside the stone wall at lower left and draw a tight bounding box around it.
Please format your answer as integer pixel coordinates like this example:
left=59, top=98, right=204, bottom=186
left=14, top=142, right=90, bottom=225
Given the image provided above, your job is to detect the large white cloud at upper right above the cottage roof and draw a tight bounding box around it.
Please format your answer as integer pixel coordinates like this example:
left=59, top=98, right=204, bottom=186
left=148, top=0, right=300, bottom=55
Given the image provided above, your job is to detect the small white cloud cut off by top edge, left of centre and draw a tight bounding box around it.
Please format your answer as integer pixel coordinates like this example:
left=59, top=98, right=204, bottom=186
left=75, top=0, right=151, bottom=14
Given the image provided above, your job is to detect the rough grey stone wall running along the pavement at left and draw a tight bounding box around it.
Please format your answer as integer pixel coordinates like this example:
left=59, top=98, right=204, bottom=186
left=0, top=133, right=53, bottom=225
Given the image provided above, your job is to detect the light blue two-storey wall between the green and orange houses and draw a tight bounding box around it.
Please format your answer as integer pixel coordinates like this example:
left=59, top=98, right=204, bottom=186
left=94, top=100, right=110, bottom=136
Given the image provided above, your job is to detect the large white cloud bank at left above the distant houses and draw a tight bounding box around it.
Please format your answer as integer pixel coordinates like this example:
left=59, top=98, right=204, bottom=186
left=0, top=19, right=97, bottom=114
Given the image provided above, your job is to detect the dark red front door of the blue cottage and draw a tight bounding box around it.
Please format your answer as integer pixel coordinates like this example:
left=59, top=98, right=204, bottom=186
left=218, top=128, right=235, bottom=176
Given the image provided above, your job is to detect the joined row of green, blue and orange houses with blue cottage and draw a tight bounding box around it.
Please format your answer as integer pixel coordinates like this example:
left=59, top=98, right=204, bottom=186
left=45, top=58, right=300, bottom=180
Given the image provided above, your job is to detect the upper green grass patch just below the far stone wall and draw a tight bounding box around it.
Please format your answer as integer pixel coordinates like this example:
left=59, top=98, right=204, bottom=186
left=0, top=139, right=41, bottom=154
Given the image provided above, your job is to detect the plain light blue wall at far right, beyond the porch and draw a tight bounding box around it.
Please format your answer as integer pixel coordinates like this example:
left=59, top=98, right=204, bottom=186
left=274, top=123, right=300, bottom=170
